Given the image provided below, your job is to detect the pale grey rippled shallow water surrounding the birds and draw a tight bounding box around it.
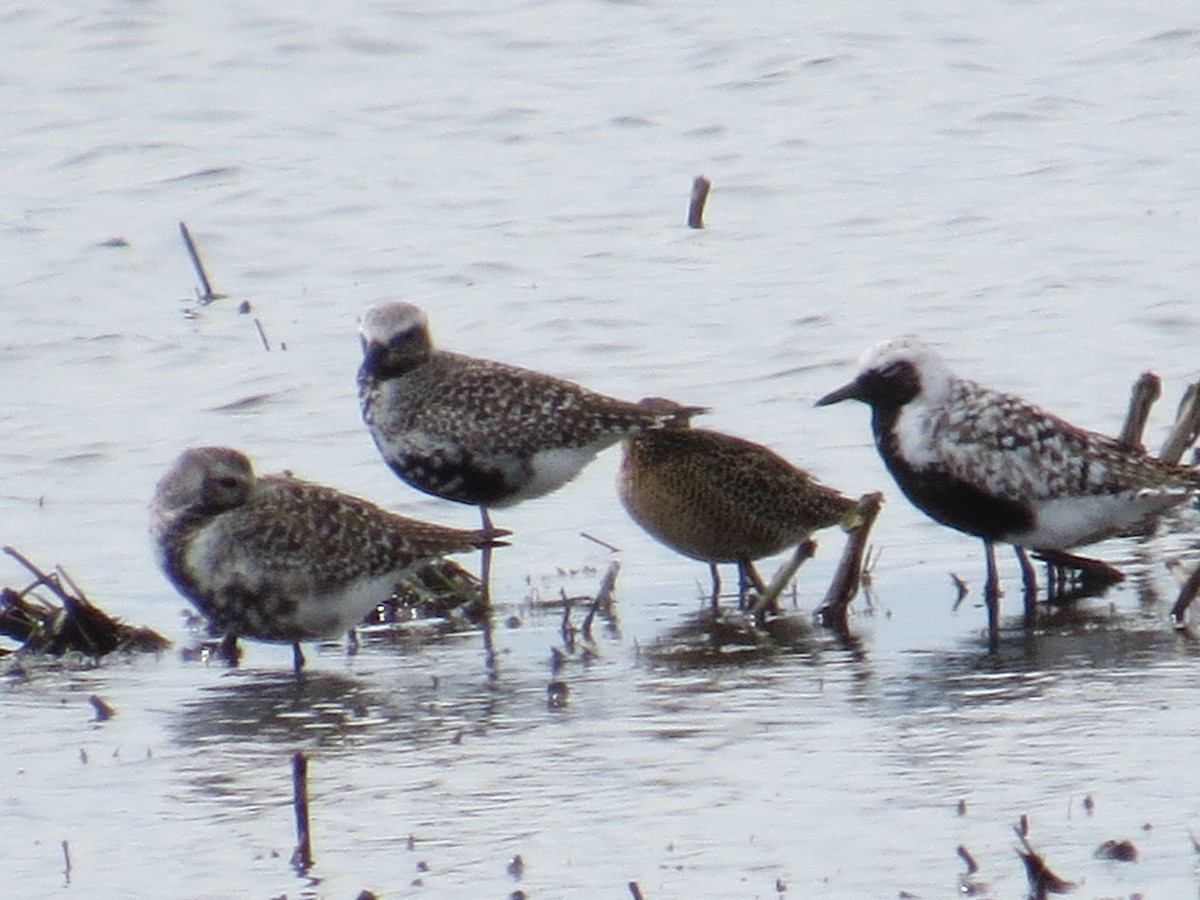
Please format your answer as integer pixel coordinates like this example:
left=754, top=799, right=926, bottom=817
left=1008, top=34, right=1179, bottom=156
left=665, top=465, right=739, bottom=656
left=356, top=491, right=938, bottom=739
left=7, top=1, right=1200, bottom=898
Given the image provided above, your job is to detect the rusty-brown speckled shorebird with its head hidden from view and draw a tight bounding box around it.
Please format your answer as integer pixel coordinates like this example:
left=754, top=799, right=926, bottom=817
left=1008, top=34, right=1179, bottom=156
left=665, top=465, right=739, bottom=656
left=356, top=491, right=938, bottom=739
left=617, top=427, right=857, bottom=611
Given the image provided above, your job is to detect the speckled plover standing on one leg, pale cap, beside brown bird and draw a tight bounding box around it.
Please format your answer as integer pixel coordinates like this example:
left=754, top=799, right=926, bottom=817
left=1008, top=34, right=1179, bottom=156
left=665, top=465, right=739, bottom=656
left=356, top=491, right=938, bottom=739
left=359, top=302, right=703, bottom=602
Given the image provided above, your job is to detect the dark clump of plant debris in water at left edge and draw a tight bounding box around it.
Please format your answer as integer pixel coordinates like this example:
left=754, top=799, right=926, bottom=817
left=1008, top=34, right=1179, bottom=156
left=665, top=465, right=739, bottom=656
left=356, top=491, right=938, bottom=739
left=0, top=547, right=170, bottom=659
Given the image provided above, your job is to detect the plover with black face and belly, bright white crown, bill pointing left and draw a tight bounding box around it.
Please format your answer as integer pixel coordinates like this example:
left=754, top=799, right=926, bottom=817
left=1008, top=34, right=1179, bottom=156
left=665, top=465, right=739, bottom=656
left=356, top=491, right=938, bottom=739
left=817, top=338, right=1200, bottom=647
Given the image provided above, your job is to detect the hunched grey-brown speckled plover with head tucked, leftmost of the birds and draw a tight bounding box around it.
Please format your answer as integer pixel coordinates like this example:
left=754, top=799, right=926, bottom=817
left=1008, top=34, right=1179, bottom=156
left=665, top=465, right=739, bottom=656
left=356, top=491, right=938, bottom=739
left=150, top=446, right=505, bottom=672
